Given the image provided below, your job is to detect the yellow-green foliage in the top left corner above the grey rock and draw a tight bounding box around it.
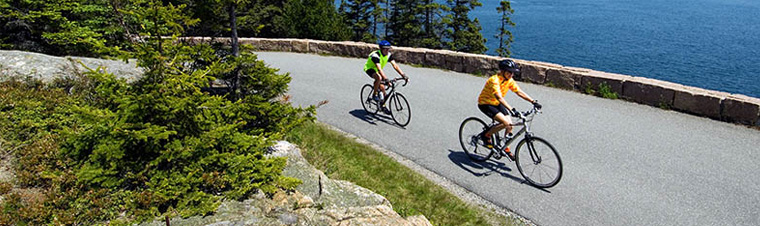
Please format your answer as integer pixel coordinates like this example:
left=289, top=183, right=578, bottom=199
left=0, top=0, right=127, bottom=56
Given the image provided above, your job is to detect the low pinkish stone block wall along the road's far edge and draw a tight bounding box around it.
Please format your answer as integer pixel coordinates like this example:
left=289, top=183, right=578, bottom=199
left=181, top=37, right=760, bottom=126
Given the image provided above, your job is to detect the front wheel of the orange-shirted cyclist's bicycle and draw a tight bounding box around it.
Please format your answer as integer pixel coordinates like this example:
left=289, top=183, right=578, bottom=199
left=515, top=137, right=562, bottom=188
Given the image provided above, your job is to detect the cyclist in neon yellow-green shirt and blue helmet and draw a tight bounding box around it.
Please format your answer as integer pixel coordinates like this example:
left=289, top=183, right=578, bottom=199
left=364, top=40, right=409, bottom=102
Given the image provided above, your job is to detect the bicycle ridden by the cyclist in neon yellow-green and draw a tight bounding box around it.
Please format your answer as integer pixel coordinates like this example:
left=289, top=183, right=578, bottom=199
left=360, top=78, right=412, bottom=127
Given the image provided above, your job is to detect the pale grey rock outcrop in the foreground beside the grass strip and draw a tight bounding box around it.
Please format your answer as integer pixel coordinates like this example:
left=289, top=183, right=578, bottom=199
left=142, top=141, right=432, bottom=226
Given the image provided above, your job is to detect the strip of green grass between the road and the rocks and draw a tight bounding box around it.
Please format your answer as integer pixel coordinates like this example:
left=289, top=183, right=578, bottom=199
left=287, top=123, right=520, bottom=225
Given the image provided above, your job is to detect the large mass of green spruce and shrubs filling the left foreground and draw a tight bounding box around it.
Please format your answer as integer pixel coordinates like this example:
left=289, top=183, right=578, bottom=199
left=0, top=0, right=314, bottom=225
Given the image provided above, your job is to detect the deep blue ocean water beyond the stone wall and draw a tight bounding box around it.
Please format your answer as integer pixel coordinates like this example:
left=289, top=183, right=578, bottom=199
left=470, top=0, right=760, bottom=97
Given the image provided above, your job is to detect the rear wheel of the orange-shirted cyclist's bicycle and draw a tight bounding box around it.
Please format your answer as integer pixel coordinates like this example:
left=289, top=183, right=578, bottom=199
left=459, top=117, right=493, bottom=162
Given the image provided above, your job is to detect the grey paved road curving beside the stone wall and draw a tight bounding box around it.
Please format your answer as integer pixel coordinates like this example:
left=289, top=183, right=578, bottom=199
left=259, top=52, right=760, bottom=225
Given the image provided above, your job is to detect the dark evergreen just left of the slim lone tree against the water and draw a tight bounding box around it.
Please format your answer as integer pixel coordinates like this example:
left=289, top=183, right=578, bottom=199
left=445, top=0, right=487, bottom=53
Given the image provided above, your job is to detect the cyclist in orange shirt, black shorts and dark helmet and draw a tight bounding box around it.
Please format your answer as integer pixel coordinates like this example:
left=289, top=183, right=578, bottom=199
left=478, top=60, right=541, bottom=159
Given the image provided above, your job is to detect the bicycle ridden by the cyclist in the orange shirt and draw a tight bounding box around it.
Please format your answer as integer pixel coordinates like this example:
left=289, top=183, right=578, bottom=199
left=459, top=106, right=562, bottom=188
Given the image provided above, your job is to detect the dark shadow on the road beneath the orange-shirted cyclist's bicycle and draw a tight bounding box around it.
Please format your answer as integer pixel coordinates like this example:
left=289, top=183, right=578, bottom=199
left=449, top=149, right=551, bottom=193
